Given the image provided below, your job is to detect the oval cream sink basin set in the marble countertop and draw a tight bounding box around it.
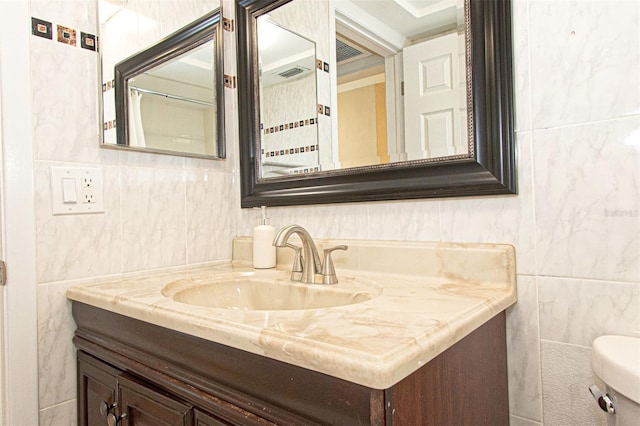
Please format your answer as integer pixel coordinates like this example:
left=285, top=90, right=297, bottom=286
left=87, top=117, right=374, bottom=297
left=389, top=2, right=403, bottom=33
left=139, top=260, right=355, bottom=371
left=162, top=277, right=380, bottom=311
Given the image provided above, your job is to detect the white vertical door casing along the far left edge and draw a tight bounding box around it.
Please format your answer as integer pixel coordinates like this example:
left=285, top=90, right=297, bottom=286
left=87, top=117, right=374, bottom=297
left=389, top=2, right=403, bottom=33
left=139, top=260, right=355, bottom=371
left=0, top=0, right=39, bottom=425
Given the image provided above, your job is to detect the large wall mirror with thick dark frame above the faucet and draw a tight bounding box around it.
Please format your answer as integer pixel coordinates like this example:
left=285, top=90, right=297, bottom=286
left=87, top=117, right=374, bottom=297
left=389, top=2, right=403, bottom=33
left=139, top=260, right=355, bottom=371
left=236, top=0, right=516, bottom=207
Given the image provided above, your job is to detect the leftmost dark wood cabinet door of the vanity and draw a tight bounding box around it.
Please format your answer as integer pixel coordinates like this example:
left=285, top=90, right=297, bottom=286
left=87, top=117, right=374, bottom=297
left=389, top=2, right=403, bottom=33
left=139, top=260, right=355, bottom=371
left=78, top=352, right=120, bottom=426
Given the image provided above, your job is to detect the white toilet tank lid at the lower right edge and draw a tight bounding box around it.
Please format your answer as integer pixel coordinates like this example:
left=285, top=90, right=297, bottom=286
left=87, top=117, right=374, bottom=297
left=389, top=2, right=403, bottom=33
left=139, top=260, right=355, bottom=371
left=591, top=336, right=640, bottom=404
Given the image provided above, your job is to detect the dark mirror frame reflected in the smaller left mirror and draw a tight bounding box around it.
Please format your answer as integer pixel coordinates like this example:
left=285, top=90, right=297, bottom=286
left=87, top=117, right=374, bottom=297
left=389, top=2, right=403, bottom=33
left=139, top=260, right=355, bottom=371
left=114, top=8, right=226, bottom=159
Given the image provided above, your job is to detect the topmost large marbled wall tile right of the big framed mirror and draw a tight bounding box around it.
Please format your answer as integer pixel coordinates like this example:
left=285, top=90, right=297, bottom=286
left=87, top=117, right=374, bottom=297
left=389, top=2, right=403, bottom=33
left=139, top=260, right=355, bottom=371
left=528, top=0, right=640, bottom=129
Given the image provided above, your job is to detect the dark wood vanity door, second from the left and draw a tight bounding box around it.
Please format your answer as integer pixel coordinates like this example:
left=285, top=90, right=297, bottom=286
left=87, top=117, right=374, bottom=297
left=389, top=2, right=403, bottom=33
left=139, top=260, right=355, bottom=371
left=118, top=376, right=193, bottom=426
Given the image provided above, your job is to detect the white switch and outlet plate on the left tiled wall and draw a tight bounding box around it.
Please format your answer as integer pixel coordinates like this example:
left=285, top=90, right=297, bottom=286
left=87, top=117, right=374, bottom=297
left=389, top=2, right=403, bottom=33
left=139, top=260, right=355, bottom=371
left=51, top=167, right=104, bottom=215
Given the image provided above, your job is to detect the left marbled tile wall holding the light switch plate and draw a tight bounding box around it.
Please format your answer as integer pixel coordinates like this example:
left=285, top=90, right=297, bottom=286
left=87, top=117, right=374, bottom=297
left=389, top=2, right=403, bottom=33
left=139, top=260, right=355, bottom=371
left=26, top=0, right=240, bottom=425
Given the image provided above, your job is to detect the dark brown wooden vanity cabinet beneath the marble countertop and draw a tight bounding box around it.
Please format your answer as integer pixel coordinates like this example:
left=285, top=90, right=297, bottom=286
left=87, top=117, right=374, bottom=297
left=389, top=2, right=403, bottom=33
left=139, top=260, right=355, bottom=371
left=73, top=302, right=509, bottom=426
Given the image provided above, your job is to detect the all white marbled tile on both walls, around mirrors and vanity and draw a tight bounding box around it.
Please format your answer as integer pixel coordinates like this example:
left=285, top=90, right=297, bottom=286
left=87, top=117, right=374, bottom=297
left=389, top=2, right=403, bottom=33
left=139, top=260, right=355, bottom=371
left=25, top=0, right=640, bottom=425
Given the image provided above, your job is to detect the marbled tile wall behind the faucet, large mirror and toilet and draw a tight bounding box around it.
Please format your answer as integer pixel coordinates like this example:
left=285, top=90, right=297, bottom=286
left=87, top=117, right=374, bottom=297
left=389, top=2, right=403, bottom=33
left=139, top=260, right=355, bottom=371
left=238, top=0, right=640, bottom=425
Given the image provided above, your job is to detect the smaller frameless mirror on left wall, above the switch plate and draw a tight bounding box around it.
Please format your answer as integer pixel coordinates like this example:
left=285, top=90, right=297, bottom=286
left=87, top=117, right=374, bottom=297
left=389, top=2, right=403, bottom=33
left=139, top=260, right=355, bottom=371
left=99, top=0, right=225, bottom=159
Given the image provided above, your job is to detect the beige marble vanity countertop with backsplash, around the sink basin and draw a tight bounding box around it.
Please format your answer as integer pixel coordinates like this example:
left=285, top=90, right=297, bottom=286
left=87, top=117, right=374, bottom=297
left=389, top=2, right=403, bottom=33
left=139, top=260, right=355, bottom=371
left=67, top=238, right=516, bottom=389
